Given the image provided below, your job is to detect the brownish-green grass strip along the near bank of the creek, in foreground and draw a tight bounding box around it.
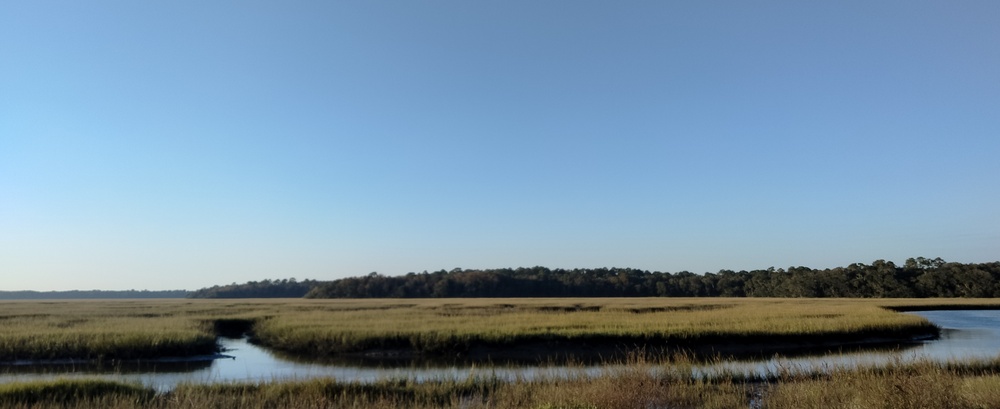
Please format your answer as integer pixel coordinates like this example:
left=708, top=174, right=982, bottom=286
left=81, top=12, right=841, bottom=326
left=9, top=361, right=1000, bottom=409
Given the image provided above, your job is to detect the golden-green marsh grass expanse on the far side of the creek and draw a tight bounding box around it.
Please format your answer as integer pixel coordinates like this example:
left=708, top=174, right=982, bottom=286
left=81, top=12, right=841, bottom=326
left=0, top=298, right=1000, bottom=362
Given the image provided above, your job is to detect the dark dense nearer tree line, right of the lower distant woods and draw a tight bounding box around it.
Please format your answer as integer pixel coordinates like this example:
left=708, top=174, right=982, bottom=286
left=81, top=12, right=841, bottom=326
left=306, top=257, right=1000, bottom=298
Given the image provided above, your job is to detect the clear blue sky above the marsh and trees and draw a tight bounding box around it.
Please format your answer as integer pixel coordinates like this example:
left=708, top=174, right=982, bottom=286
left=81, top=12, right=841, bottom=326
left=0, top=0, right=1000, bottom=290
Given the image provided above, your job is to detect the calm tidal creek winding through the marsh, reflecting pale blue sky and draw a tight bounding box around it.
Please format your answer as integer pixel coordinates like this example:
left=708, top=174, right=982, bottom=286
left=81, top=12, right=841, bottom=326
left=0, top=310, right=1000, bottom=391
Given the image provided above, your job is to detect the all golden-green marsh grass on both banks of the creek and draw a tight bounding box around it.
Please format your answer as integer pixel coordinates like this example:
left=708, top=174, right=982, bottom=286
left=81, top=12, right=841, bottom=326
left=0, top=298, right=1000, bottom=408
